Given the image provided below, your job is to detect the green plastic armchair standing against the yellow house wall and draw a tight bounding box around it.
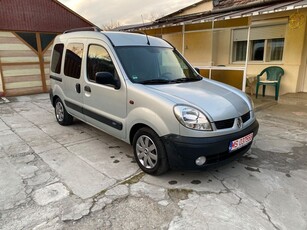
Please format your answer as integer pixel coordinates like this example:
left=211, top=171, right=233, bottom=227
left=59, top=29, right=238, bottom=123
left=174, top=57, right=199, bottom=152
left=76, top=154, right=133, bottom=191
left=256, top=66, right=285, bottom=101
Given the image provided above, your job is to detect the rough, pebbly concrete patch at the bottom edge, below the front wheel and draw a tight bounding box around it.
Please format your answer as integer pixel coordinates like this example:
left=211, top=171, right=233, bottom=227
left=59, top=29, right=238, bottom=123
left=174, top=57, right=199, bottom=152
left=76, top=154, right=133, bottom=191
left=72, top=196, right=179, bottom=230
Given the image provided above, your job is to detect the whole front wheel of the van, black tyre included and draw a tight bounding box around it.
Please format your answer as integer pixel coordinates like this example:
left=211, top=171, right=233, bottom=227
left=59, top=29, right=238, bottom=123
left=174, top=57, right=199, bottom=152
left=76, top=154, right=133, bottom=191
left=133, top=127, right=169, bottom=175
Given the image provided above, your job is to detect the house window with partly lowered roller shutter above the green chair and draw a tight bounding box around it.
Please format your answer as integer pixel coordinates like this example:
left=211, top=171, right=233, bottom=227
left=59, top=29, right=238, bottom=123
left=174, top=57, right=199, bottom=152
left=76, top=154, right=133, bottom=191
left=232, top=24, right=286, bottom=62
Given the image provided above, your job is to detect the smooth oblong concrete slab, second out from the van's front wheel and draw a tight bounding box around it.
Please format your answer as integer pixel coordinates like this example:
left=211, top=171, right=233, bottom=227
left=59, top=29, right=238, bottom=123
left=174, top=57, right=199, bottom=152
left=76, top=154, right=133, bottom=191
left=40, top=148, right=116, bottom=199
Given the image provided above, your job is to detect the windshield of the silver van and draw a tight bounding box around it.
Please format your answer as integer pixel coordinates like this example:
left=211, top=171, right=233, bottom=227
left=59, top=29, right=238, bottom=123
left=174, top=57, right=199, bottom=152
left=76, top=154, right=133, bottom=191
left=116, top=46, right=201, bottom=84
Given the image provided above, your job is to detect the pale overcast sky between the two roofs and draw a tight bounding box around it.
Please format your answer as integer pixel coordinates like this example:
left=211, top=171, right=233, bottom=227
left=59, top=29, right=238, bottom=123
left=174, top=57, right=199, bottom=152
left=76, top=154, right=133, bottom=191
left=59, top=0, right=200, bottom=27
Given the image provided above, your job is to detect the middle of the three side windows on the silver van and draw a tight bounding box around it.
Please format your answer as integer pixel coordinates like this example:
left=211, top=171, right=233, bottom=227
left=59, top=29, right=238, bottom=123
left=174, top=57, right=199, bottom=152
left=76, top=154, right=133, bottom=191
left=64, top=43, right=83, bottom=78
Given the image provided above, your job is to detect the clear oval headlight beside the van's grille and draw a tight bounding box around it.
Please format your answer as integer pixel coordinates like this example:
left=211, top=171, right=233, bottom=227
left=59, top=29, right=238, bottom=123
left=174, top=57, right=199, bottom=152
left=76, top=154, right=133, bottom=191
left=174, top=105, right=212, bottom=131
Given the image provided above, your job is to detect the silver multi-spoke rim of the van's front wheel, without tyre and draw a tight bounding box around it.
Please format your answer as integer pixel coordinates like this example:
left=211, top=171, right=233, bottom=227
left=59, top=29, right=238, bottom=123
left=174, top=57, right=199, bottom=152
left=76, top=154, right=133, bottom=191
left=136, top=135, right=158, bottom=169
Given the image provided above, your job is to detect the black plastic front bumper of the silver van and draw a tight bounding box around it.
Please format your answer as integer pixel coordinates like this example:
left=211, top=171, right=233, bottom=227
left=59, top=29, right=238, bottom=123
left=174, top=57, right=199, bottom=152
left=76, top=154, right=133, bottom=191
left=162, top=120, right=259, bottom=169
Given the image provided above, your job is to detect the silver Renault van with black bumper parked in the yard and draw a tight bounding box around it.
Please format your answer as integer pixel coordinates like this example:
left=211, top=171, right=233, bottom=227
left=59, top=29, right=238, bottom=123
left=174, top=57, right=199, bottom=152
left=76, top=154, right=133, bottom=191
left=50, top=28, right=259, bottom=175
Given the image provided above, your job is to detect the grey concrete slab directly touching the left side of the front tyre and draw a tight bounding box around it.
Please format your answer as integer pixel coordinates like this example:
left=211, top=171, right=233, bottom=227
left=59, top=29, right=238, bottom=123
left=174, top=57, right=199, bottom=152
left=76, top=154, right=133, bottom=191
left=67, top=140, right=139, bottom=180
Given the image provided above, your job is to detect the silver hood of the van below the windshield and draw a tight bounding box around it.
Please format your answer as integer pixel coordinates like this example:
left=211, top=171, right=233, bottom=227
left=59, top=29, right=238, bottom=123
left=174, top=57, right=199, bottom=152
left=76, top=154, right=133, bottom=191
left=147, top=79, right=250, bottom=121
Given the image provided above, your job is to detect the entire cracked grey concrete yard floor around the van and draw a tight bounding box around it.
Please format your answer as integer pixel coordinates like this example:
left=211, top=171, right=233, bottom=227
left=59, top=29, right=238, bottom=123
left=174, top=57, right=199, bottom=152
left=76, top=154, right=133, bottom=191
left=0, top=94, right=307, bottom=230
